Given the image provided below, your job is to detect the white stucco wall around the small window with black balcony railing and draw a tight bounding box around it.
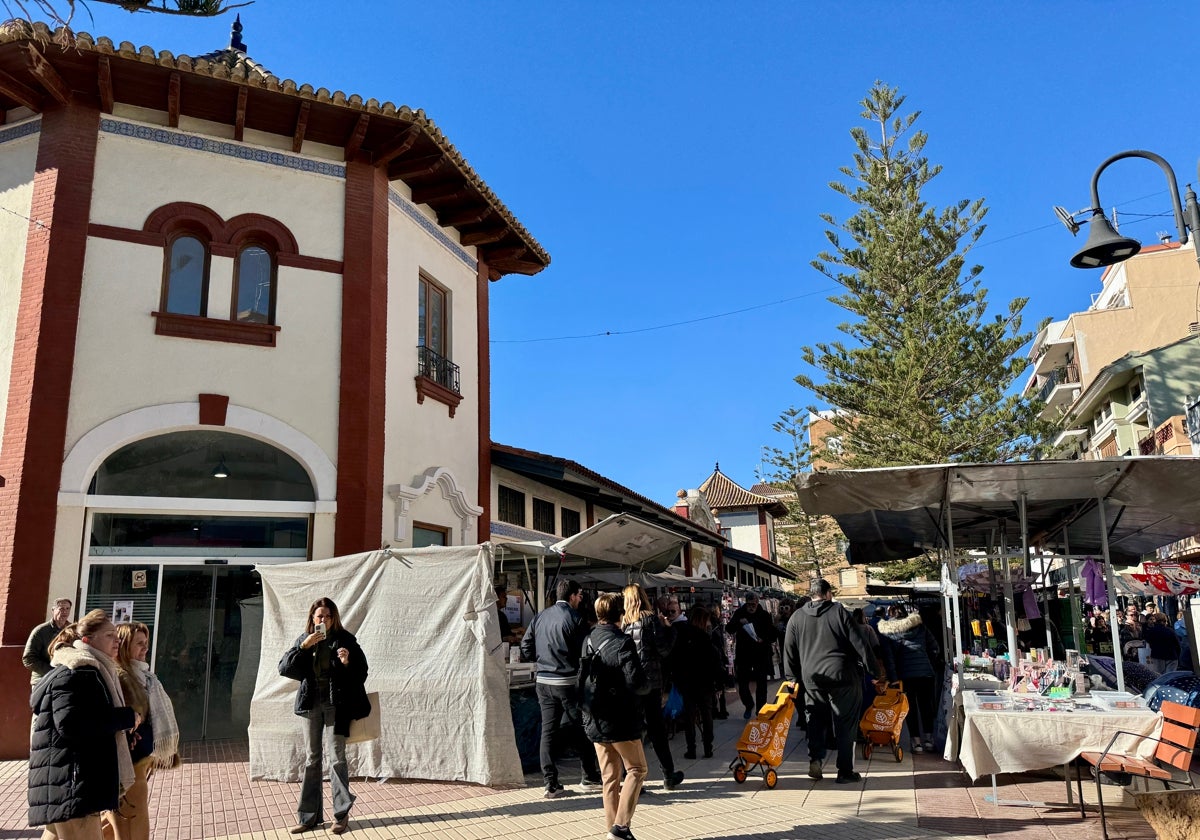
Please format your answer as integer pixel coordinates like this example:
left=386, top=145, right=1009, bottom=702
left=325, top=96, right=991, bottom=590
left=384, top=191, right=487, bottom=542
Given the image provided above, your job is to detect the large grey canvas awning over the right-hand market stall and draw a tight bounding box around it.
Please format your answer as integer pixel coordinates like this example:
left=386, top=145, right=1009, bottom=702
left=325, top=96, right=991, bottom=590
left=798, top=456, right=1200, bottom=564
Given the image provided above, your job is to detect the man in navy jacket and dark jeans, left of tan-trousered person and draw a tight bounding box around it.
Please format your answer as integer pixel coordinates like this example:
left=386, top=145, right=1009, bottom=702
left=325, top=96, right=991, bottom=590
left=521, top=578, right=600, bottom=799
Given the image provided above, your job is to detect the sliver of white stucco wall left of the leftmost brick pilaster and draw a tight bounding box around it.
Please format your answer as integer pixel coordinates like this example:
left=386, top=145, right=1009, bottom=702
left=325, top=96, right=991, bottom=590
left=0, top=126, right=41, bottom=446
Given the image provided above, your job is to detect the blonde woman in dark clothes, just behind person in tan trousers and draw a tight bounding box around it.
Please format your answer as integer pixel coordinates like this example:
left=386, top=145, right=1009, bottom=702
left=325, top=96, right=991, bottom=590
left=620, top=583, right=681, bottom=791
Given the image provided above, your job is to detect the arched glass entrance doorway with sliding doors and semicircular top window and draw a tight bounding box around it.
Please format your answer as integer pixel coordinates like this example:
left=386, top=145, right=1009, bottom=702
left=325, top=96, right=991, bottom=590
left=83, top=428, right=316, bottom=739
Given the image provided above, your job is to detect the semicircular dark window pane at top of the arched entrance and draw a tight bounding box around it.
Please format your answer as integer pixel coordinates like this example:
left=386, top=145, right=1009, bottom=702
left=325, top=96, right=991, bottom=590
left=89, top=431, right=316, bottom=502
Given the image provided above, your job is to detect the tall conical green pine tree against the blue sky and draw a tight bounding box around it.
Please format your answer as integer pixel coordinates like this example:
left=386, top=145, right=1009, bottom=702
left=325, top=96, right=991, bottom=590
left=796, top=82, right=1044, bottom=468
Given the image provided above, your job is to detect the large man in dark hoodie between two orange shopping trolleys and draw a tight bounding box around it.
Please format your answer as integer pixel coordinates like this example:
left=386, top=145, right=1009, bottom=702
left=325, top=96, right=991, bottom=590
left=784, top=578, right=887, bottom=785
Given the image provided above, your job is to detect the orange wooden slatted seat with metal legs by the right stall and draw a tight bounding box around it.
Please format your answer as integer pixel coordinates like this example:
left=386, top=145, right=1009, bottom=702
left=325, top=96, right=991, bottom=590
left=1075, top=701, right=1200, bottom=840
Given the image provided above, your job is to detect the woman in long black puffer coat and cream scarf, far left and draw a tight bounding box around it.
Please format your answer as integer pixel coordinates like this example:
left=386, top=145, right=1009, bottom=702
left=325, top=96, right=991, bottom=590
left=29, top=610, right=142, bottom=840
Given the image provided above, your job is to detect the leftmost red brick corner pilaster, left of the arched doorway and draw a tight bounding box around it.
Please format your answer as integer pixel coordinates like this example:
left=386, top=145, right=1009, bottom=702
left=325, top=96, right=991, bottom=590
left=0, top=103, right=100, bottom=758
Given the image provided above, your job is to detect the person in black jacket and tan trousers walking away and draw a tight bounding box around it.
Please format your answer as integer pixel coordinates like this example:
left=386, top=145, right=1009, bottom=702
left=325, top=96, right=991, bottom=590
left=581, top=592, right=650, bottom=840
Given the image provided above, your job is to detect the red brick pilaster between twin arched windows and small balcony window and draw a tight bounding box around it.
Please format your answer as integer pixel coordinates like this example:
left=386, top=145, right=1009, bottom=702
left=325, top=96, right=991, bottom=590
left=334, top=160, right=388, bottom=554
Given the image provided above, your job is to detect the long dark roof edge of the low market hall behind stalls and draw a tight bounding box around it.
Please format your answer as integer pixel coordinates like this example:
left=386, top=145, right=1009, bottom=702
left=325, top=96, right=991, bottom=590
left=492, top=443, right=725, bottom=547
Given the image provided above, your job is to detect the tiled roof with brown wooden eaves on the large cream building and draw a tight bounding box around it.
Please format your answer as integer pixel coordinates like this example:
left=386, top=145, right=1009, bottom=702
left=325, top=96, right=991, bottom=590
left=0, top=20, right=550, bottom=280
